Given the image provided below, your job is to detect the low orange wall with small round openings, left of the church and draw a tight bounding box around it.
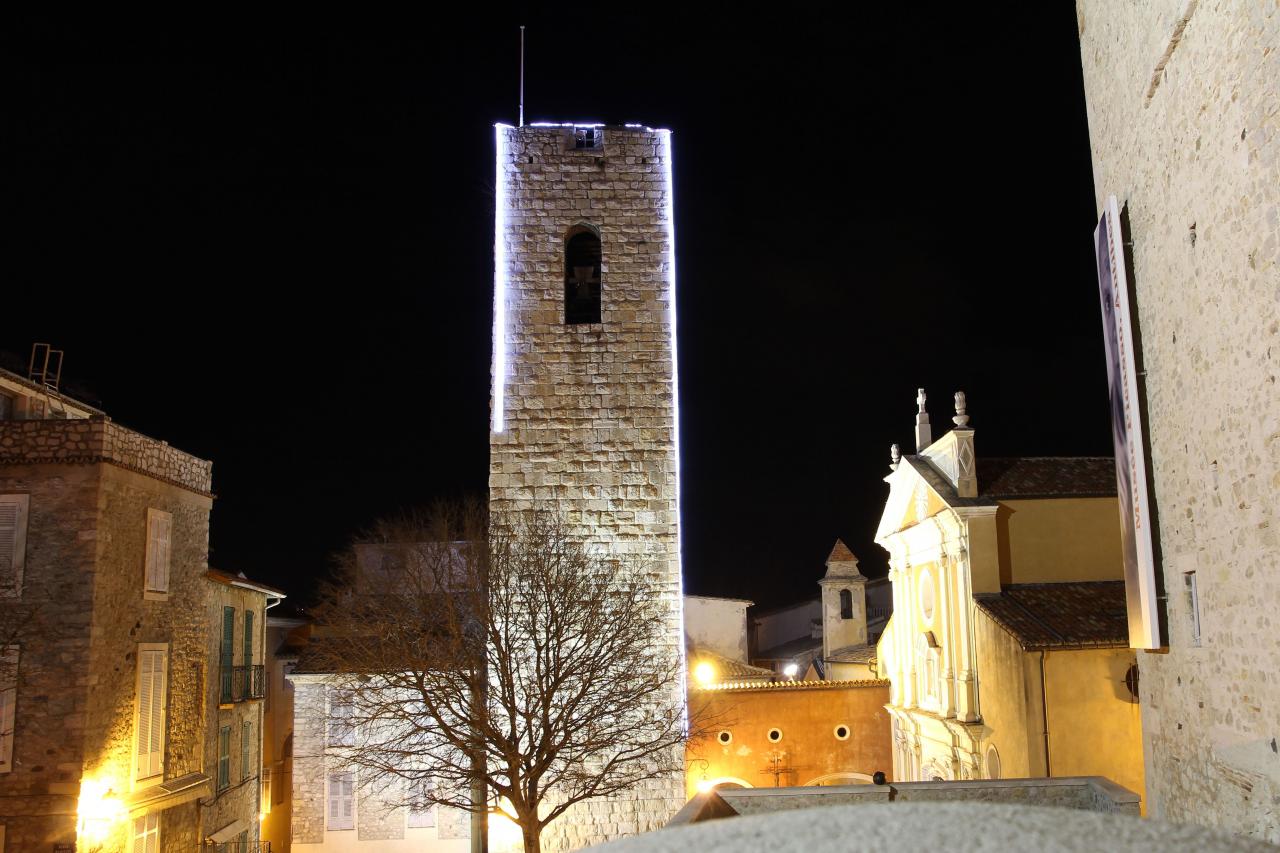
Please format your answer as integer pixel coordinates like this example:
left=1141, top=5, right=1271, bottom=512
left=685, top=681, right=893, bottom=797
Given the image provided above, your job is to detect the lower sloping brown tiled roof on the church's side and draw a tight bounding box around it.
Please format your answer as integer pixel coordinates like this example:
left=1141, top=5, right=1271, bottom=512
left=974, top=580, right=1129, bottom=652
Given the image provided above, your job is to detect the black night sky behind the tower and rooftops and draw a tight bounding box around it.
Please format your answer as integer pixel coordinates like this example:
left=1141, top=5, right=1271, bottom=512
left=0, top=4, right=1111, bottom=605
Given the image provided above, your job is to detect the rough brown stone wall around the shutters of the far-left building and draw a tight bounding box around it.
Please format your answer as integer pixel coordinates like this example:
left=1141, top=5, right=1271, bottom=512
left=0, top=450, right=211, bottom=850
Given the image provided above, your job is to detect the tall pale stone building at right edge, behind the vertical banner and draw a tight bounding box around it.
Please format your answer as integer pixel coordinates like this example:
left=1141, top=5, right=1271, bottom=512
left=1076, top=0, right=1280, bottom=841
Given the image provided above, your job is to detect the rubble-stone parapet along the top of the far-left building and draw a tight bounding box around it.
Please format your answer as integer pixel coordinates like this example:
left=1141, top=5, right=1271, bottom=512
left=0, top=418, right=214, bottom=496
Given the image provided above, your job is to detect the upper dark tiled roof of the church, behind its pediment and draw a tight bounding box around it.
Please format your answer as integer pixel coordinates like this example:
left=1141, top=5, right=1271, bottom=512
left=978, top=456, right=1116, bottom=498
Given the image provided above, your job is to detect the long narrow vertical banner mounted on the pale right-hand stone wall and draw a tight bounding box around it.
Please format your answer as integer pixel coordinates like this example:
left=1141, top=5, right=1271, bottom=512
left=1093, top=196, right=1160, bottom=648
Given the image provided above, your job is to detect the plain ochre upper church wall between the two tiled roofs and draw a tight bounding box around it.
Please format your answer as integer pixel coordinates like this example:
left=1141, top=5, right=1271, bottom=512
left=997, top=497, right=1124, bottom=584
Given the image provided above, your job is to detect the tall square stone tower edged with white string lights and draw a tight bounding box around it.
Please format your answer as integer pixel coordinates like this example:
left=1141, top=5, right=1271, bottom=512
left=489, top=124, right=684, bottom=849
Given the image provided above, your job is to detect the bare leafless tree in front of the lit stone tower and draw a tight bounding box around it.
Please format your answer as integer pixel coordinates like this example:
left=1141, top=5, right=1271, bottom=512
left=308, top=507, right=689, bottom=853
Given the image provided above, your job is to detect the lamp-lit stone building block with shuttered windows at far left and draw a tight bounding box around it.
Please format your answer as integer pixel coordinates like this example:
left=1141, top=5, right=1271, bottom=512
left=0, top=361, right=280, bottom=852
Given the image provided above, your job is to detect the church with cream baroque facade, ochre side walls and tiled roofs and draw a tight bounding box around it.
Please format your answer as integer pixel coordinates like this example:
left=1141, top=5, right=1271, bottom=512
left=876, top=391, right=1143, bottom=794
